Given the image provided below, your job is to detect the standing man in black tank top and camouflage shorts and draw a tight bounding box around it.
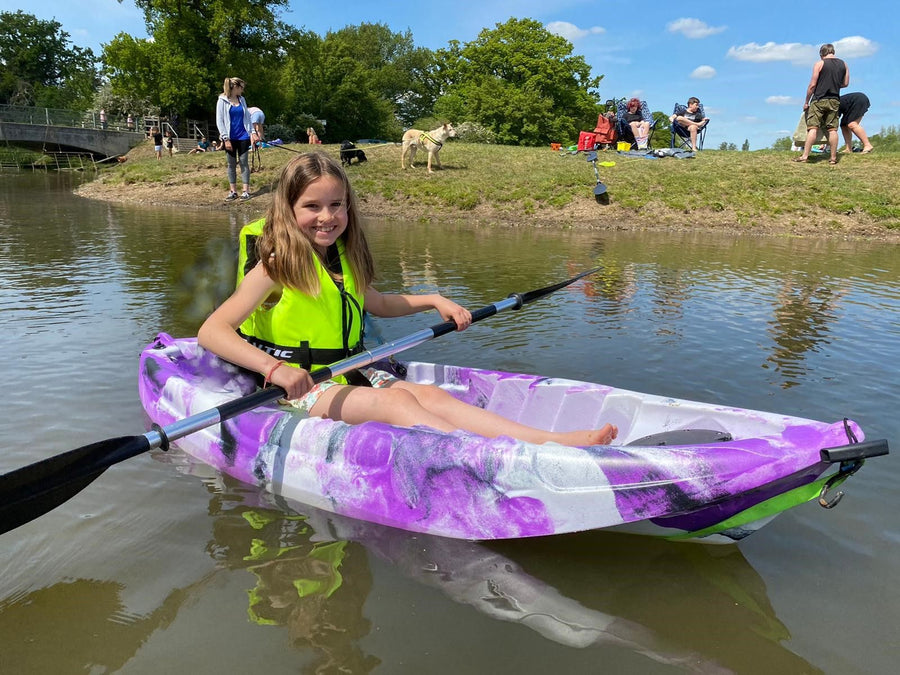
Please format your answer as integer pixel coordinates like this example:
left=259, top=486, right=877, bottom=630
left=793, top=43, right=850, bottom=164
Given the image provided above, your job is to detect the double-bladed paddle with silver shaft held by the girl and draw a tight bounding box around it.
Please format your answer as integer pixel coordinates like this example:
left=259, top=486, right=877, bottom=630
left=0, top=267, right=600, bottom=534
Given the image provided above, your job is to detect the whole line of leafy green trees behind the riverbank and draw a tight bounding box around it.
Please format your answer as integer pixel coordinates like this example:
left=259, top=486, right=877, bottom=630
left=0, top=0, right=603, bottom=145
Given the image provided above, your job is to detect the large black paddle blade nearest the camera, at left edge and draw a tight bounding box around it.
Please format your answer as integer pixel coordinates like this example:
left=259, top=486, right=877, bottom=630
left=0, top=436, right=150, bottom=534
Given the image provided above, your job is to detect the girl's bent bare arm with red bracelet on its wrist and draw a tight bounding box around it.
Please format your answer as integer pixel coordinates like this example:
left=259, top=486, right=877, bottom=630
left=197, top=264, right=313, bottom=398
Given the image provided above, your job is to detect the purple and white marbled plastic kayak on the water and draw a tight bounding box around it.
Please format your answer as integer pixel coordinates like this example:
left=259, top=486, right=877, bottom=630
left=139, top=333, right=888, bottom=543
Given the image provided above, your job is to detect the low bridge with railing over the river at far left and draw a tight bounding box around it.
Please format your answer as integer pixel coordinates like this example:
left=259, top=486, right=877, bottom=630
left=0, top=105, right=145, bottom=157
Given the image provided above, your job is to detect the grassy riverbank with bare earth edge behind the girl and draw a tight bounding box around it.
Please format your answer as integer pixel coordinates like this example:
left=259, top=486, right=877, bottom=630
left=78, top=142, right=900, bottom=240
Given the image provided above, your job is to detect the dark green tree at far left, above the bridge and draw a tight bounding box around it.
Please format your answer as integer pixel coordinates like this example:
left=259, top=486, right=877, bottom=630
left=0, top=10, right=99, bottom=110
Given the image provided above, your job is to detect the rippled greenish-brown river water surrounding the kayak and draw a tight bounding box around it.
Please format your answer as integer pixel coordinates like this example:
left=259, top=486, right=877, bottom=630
left=0, top=174, right=900, bottom=675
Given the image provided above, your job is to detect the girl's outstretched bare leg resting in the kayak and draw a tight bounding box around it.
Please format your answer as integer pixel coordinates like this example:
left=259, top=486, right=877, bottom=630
left=310, top=381, right=618, bottom=446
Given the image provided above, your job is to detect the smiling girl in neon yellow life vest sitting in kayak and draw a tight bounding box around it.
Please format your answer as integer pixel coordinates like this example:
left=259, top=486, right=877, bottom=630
left=198, top=152, right=617, bottom=446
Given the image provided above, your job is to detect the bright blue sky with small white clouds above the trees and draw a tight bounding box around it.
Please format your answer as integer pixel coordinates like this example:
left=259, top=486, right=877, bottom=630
left=8, top=0, right=900, bottom=150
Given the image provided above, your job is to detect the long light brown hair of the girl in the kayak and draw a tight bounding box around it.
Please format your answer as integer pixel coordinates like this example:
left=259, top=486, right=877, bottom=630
left=256, top=152, right=375, bottom=295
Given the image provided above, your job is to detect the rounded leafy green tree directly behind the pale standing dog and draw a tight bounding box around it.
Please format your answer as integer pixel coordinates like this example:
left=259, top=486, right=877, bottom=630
left=434, top=18, right=602, bottom=145
